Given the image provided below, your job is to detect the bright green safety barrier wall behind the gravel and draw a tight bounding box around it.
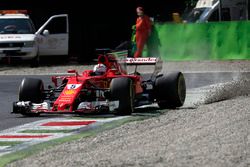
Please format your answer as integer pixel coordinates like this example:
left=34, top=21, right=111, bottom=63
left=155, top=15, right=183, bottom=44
left=144, top=21, right=250, bottom=61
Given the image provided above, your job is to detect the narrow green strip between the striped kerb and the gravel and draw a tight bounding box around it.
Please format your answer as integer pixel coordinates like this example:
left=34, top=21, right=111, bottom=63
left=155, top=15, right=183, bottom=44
left=0, top=116, right=149, bottom=167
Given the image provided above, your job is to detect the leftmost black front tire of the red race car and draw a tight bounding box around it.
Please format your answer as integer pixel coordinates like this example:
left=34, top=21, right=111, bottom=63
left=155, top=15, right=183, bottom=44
left=19, top=78, right=44, bottom=116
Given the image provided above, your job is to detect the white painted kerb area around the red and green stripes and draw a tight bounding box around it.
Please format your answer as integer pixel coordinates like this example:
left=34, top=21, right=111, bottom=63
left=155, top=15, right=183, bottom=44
left=0, top=116, right=129, bottom=156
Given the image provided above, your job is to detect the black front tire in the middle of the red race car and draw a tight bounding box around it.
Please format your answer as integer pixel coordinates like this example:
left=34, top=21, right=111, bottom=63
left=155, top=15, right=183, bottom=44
left=110, top=78, right=134, bottom=115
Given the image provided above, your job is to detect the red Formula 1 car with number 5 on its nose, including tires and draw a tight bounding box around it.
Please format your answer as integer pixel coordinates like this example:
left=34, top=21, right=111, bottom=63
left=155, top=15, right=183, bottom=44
left=13, top=52, right=186, bottom=116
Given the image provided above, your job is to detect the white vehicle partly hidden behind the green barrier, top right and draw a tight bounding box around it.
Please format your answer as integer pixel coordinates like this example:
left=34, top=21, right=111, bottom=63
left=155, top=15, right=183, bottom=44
left=183, top=0, right=248, bottom=22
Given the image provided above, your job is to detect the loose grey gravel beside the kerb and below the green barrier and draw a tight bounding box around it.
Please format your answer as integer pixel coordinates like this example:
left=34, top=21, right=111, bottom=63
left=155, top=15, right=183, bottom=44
left=2, top=61, right=250, bottom=167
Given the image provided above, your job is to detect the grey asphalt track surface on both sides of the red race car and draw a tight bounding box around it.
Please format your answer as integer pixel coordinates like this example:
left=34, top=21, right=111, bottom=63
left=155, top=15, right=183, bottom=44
left=0, top=72, right=250, bottom=130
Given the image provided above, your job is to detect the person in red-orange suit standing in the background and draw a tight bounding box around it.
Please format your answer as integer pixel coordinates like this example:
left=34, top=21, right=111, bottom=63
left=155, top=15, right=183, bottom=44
left=134, top=7, right=152, bottom=58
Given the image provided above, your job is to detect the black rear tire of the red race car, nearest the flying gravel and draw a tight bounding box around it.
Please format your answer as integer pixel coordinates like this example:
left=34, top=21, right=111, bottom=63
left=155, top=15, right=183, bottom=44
left=154, top=72, right=186, bottom=109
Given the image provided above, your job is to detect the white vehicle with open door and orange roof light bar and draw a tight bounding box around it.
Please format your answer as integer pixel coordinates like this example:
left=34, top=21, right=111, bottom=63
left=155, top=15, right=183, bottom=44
left=0, top=10, right=69, bottom=66
